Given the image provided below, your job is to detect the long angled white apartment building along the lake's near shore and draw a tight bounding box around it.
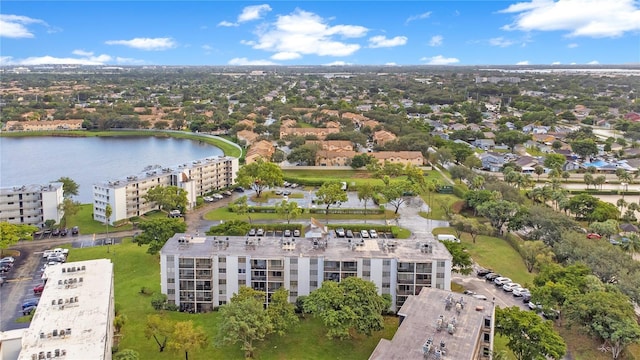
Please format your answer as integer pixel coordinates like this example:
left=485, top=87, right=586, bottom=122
left=93, top=156, right=239, bottom=224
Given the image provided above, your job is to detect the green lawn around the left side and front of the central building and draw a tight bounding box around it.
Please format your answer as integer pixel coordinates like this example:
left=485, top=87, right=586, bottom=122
left=63, top=241, right=398, bottom=360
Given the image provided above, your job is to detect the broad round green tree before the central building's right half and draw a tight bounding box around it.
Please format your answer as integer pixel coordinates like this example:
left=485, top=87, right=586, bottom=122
left=304, top=276, right=388, bottom=339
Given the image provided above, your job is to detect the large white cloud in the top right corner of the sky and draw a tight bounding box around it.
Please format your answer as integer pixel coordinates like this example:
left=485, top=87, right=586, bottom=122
left=500, top=0, right=640, bottom=38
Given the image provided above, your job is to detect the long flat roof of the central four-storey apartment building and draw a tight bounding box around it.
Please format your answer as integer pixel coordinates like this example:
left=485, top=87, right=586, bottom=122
left=161, top=233, right=451, bottom=262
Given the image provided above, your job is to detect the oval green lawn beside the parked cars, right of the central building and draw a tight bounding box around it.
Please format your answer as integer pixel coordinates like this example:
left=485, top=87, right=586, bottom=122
left=433, top=228, right=535, bottom=286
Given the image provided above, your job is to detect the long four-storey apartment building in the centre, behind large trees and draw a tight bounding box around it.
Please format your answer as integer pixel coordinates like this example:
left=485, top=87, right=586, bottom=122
left=160, top=231, right=451, bottom=312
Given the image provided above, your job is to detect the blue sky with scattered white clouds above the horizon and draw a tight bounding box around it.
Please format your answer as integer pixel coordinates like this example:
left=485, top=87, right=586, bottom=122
left=0, top=0, right=640, bottom=65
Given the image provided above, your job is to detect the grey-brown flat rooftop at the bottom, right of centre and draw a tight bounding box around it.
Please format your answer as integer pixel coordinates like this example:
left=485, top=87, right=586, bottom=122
left=369, top=287, right=494, bottom=360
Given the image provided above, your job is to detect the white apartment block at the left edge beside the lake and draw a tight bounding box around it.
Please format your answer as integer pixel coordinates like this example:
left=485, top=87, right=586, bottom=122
left=0, top=182, right=64, bottom=227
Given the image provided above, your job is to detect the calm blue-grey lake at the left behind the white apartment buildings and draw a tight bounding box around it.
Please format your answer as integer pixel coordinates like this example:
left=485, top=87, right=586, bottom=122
left=0, top=136, right=224, bottom=204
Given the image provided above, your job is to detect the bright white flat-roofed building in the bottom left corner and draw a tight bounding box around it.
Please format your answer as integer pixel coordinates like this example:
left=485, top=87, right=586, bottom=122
left=17, top=259, right=114, bottom=360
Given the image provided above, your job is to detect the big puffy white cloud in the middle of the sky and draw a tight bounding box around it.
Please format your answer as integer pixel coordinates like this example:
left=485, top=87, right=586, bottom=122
left=241, top=9, right=369, bottom=56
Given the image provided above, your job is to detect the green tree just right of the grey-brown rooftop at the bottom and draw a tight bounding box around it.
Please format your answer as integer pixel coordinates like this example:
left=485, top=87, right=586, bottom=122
left=496, top=306, right=567, bottom=360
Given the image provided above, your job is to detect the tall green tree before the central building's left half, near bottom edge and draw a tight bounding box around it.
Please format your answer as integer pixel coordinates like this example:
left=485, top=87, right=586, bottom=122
left=216, top=286, right=273, bottom=358
